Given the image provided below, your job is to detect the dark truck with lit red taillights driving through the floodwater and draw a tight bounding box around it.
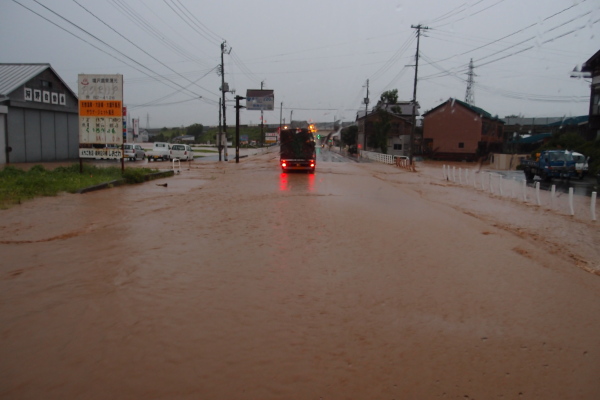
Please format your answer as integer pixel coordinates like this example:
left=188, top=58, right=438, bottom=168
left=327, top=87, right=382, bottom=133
left=279, top=128, right=317, bottom=172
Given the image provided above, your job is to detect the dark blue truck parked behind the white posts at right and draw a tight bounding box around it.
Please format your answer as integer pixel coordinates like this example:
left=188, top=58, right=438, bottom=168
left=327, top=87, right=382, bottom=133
left=521, top=150, right=576, bottom=180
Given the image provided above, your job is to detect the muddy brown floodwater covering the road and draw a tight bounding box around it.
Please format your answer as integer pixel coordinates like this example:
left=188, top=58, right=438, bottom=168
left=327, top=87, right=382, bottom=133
left=0, top=154, right=600, bottom=400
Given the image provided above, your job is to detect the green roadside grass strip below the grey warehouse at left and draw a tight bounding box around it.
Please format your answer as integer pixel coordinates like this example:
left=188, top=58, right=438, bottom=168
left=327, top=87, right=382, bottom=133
left=0, top=164, right=156, bottom=209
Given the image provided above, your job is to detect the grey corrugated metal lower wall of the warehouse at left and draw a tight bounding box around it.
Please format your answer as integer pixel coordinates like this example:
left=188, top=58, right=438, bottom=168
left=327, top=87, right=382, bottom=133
left=7, top=107, right=79, bottom=163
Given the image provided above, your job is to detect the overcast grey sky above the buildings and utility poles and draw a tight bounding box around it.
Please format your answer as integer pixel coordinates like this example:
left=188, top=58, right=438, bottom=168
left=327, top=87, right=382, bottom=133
left=0, top=0, right=600, bottom=127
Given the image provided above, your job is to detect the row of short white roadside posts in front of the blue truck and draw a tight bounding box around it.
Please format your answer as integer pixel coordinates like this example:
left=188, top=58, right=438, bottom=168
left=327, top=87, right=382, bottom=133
left=442, top=165, right=597, bottom=221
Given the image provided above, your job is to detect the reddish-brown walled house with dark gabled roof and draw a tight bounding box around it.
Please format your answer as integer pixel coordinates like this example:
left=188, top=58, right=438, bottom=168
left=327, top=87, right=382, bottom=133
left=423, top=98, right=504, bottom=161
